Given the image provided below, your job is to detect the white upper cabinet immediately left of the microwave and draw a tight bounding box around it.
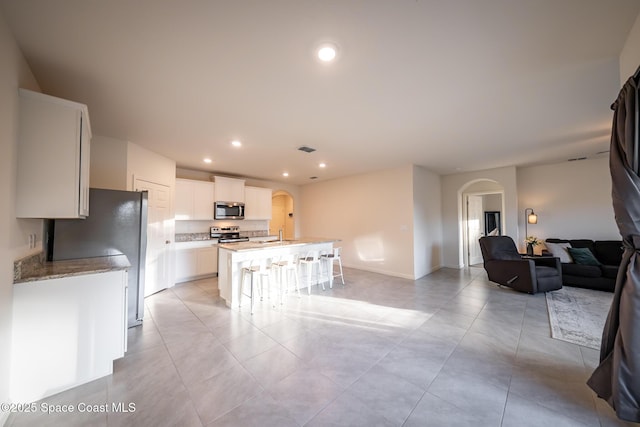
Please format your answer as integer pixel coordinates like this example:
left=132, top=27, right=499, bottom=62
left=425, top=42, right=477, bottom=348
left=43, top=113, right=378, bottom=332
left=175, top=178, right=216, bottom=221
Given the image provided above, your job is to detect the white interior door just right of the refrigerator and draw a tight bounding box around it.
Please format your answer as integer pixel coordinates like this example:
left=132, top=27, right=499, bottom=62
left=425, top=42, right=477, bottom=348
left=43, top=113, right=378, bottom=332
left=135, top=179, right=174, bottom=297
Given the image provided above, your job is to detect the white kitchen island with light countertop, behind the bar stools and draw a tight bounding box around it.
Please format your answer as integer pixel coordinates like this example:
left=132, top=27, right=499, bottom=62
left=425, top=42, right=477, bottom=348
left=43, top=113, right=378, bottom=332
left=218, top=237, right=340, bottom=308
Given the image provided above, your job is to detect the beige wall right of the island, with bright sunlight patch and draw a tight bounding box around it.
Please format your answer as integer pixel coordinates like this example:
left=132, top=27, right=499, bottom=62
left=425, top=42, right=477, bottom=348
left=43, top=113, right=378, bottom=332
left=299, top=165, right=414, bottom=278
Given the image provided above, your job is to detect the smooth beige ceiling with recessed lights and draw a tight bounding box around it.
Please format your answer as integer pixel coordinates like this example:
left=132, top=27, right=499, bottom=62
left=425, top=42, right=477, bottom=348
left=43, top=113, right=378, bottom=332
left=0, top=0, right=640, bottom=184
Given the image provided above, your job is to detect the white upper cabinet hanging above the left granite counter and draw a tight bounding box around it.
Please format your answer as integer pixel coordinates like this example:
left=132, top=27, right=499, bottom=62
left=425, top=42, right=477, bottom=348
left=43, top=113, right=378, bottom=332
left=16, top=89, right=91, bottom=218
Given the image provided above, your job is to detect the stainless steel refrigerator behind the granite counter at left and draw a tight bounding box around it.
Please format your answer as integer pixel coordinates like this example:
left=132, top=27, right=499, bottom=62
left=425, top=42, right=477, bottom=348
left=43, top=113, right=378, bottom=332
left=45, top=188, right=148, bottom=327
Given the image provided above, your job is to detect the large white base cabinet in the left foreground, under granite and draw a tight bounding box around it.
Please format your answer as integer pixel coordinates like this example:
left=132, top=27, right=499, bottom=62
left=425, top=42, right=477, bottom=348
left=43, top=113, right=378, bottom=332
left=11, top=270, right=127, bottom=402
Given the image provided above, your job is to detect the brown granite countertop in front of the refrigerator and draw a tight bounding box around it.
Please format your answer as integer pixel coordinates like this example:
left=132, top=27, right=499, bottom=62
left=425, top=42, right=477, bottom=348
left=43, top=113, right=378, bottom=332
left=13, top=254, right=131, bottom=284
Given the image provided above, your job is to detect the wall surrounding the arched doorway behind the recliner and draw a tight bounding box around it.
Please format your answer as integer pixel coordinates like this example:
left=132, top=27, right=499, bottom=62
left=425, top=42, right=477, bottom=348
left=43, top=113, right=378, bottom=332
left=441, top=166, right=518, bottom=268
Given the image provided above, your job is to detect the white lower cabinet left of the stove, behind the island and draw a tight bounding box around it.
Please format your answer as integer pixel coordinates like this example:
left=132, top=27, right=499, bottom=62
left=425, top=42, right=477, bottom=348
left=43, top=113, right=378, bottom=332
left=175, top=240, right=218, bottom=283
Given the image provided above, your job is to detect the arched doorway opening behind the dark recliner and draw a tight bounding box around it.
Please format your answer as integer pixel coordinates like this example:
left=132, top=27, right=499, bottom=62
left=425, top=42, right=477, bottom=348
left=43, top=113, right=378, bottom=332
left=458, top=179, right=506, bottom=267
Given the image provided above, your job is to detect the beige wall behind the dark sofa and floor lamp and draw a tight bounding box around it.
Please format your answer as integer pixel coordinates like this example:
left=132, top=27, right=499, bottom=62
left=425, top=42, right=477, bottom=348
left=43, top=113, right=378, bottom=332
left=518, top=157, right=620, bottom=244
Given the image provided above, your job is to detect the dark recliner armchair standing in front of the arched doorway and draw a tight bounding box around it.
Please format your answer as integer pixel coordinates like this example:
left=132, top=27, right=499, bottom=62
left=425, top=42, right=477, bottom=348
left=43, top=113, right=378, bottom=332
left=480, top=236, right=562, bottom=294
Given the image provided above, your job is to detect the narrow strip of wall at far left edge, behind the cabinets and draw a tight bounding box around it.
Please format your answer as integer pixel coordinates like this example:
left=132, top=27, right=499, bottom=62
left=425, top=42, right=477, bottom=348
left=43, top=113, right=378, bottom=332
left=0, top=12, right=42, bottom=425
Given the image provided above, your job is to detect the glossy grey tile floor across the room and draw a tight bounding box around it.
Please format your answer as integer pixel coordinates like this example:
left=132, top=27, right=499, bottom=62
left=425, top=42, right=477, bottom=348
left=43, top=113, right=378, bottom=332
left=7, top=268, right=636, bottom=427
